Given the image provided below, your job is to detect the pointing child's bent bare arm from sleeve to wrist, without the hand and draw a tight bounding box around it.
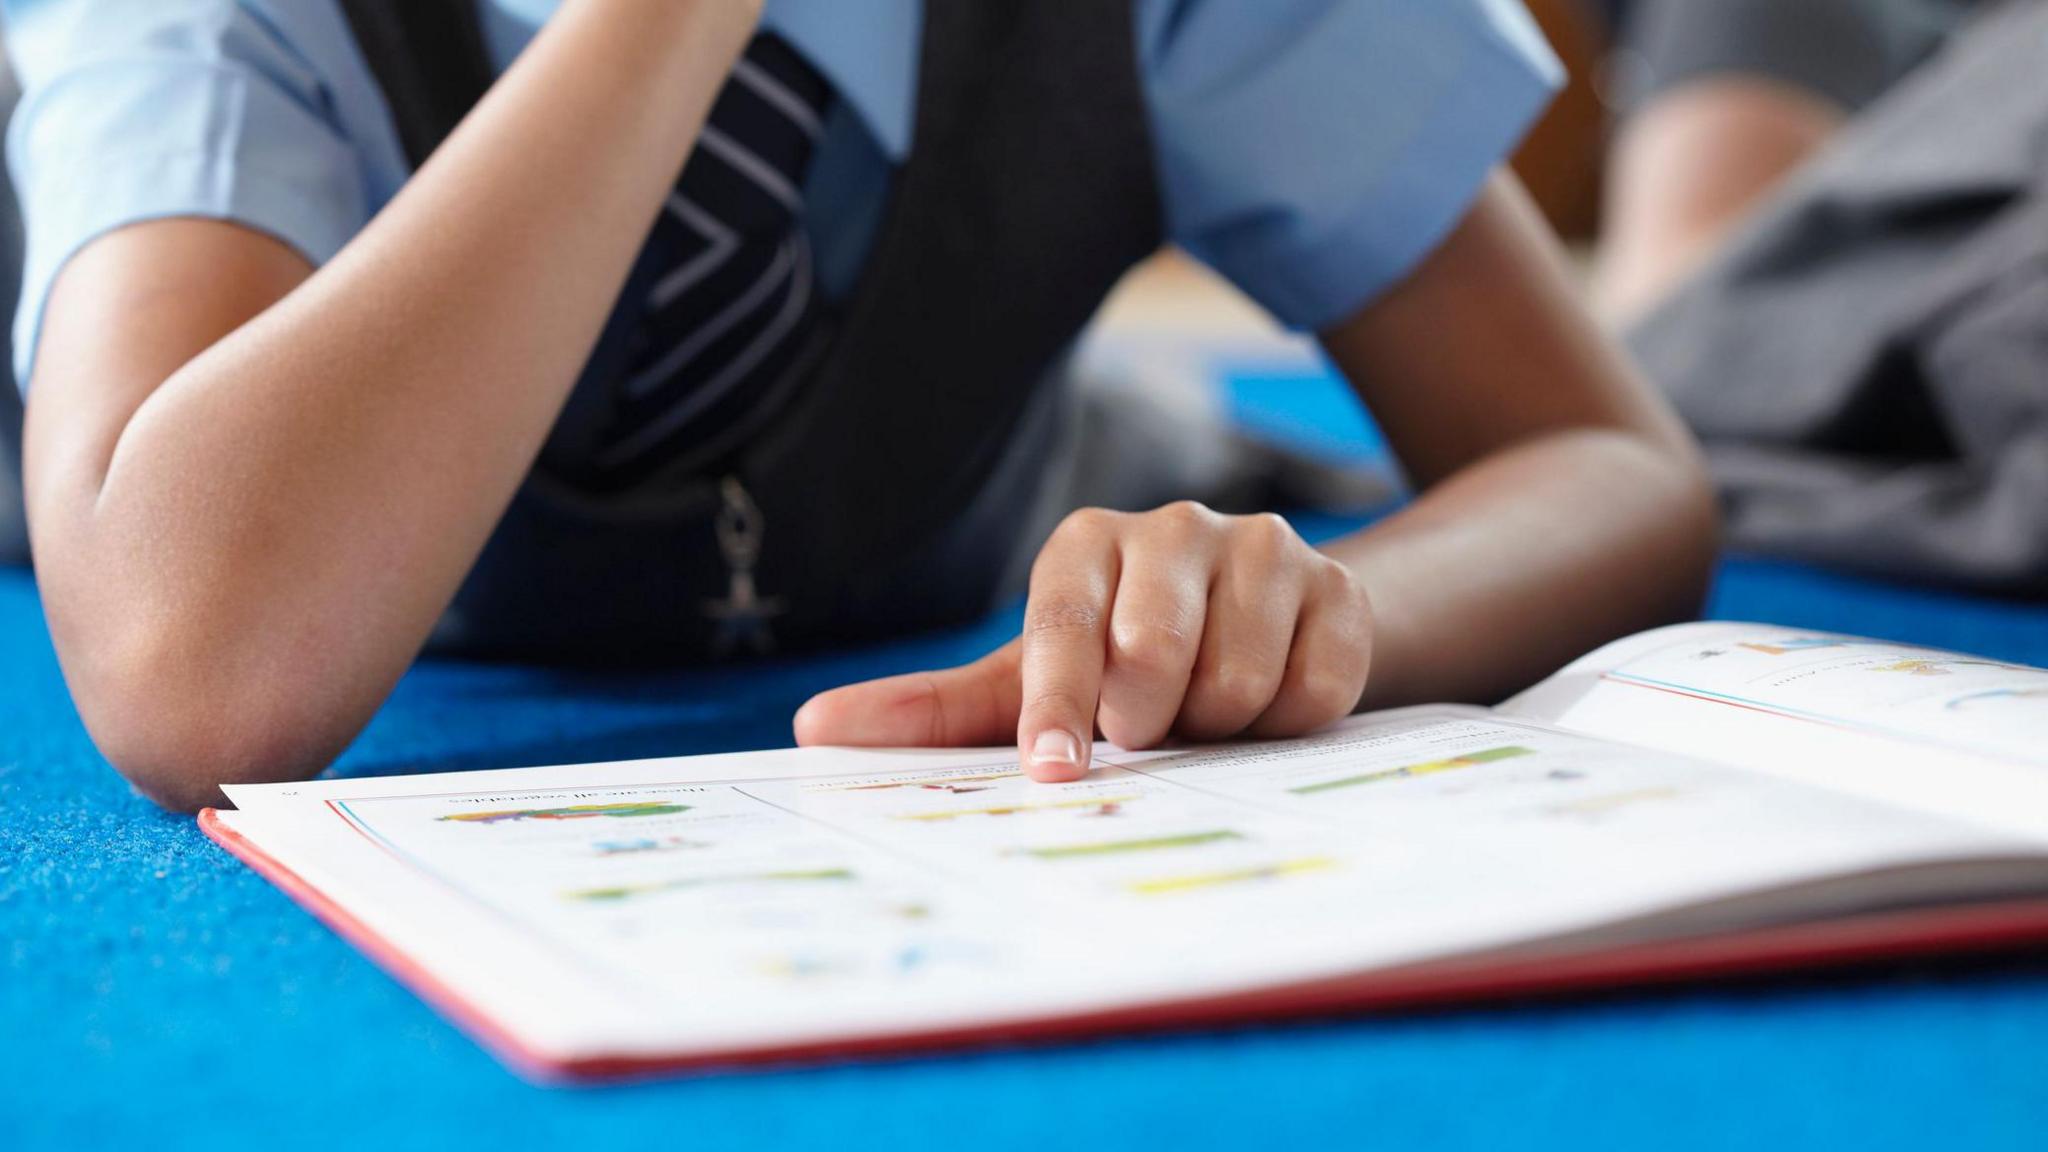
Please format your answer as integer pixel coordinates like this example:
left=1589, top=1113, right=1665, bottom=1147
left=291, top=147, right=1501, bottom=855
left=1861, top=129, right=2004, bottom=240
left=1323, top=178, right=1716, bottom=707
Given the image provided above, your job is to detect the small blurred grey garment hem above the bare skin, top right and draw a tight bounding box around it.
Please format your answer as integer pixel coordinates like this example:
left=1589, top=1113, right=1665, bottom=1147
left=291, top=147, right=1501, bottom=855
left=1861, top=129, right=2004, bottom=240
left=1602, top=0, right=1978, bottom=111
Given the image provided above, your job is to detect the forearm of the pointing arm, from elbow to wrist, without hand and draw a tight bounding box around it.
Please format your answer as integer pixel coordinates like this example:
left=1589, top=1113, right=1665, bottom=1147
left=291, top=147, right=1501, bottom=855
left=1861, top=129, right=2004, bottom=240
left=1323, top=430, right=1714, bottom=709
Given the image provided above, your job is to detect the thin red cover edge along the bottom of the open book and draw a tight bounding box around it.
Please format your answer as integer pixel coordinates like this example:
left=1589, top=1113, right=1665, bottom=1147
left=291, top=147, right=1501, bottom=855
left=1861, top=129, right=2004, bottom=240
left=199, top=808, right=2048, bottom=1082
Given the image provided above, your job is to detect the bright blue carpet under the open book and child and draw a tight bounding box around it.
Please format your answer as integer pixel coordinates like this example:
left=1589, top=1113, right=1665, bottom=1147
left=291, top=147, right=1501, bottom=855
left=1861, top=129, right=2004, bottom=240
left=0, top=373, right=2048, bottom=1150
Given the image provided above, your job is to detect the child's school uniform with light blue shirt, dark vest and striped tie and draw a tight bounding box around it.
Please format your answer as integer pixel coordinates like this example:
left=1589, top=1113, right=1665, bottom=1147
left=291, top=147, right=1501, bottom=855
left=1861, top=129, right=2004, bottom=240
left=0, top=0, right=1559, bottom=658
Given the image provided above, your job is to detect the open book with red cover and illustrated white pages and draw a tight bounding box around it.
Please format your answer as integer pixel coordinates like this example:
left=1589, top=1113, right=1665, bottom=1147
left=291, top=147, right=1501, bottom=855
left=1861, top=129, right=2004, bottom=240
left=201, top=623, right=2048, bottom=1078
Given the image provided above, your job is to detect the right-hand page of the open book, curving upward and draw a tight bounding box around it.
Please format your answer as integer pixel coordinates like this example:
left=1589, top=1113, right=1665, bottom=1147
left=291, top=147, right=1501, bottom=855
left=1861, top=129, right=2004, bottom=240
left=1501, top=623, right=2048, bottom=834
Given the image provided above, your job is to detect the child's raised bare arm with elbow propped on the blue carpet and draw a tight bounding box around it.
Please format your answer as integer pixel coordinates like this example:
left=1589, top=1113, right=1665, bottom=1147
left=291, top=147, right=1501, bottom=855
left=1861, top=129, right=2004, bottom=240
left=27, top=0, right=758, bottom=808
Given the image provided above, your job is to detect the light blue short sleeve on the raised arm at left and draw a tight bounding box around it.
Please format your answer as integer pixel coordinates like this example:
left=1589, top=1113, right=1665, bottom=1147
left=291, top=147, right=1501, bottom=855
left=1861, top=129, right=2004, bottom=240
left=4, top=0, right=369, bottom=387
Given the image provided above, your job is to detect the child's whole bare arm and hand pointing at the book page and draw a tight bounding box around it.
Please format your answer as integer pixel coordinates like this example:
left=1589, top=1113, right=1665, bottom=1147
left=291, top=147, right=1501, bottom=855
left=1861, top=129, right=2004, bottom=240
left=797, top=178, right=1714, bottom=779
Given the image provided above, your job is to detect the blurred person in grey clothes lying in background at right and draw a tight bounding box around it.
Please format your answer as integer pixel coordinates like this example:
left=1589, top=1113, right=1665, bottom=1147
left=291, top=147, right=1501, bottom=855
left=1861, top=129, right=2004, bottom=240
left=1595, top=0, right=2048, bottom=596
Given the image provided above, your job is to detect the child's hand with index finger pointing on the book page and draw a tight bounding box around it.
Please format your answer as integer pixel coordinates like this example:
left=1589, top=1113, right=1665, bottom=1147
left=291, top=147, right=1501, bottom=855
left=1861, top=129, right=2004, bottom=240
left=797, top=504, right=1372, bottom=781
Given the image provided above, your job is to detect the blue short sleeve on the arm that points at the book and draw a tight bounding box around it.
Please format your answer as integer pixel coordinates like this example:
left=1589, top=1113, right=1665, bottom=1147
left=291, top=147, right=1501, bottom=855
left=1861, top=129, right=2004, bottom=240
left=1137, top=0, right=1563, bottom=330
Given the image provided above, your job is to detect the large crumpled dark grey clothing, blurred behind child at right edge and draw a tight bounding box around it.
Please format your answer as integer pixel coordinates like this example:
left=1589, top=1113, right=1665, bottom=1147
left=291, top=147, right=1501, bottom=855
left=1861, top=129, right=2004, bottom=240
left=1630, top=0, right=2048, bottom=594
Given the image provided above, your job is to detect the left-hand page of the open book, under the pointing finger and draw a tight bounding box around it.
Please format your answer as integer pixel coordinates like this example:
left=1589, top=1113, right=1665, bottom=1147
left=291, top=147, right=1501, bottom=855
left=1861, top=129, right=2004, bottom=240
left=216, top=709, right=2036, bottom=1060
